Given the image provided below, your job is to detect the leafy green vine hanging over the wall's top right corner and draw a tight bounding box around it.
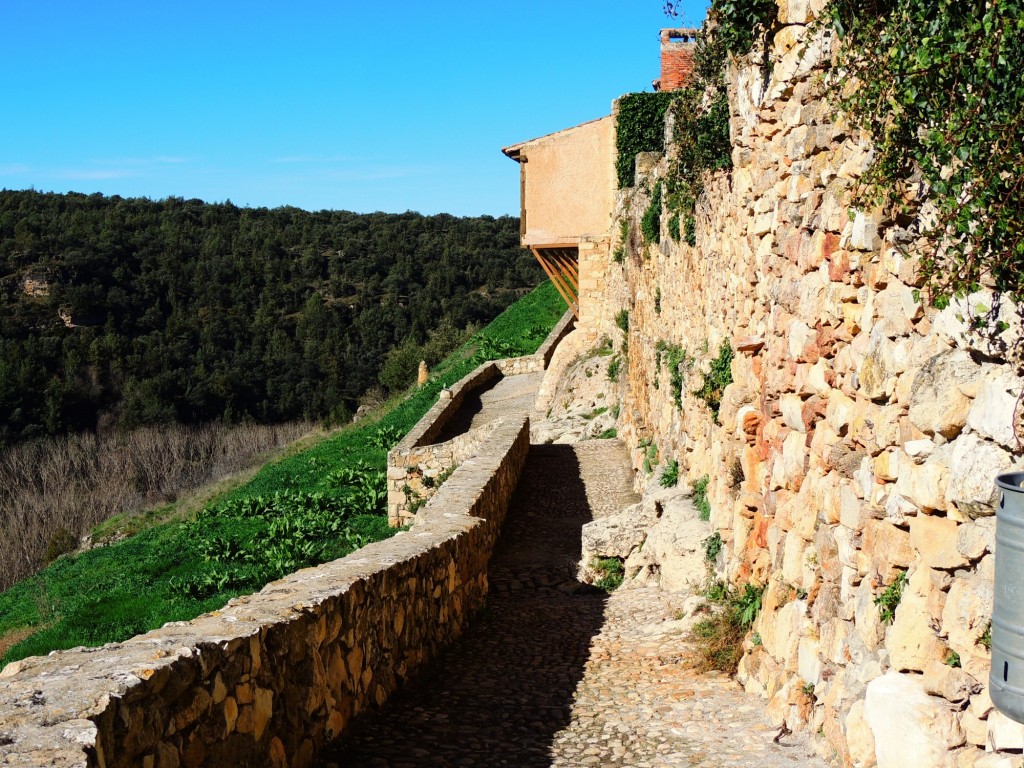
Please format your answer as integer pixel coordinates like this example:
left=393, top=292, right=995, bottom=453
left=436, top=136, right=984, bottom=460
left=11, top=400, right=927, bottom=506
left=825, top=0, right=1024, bottom=306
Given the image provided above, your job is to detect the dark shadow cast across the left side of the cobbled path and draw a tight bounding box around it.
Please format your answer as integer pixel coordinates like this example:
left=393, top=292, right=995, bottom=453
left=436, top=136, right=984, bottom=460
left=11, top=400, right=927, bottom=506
left=321, top=445, right=606, bottom=768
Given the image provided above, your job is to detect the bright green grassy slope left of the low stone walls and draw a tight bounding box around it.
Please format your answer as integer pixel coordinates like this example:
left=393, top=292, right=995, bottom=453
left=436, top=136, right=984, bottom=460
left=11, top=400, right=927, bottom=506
left=0, top=283, right=565, bottom=664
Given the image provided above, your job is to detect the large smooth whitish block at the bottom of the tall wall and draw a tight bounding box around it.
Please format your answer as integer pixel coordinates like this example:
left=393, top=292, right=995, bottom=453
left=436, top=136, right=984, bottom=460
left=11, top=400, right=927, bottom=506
left=864, top=671, right=965, bottom=768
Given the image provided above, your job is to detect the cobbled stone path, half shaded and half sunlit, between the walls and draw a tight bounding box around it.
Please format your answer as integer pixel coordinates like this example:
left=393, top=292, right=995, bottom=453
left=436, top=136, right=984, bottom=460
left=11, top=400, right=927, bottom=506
left=322, top=380, right=824, bottom=768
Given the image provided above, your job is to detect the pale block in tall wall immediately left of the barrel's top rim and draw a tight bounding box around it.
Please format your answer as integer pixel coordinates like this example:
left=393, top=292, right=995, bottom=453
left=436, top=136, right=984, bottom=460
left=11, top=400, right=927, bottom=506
left=945, top=434, right=1014, bottom=519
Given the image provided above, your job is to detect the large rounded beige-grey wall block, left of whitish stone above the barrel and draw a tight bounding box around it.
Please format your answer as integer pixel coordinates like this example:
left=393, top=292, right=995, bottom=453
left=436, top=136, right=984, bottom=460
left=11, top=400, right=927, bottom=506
left=909, top=349, right=982, bottom=439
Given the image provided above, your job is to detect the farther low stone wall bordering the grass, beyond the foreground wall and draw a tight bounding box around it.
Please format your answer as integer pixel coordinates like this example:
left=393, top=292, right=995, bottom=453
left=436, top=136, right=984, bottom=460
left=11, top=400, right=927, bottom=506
left=387, top=311, right=575, bottom=526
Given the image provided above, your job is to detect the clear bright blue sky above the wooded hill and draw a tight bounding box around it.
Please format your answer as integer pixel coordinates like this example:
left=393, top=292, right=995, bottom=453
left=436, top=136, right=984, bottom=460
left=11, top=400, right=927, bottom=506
left=0, top=0, right=707, bottom=216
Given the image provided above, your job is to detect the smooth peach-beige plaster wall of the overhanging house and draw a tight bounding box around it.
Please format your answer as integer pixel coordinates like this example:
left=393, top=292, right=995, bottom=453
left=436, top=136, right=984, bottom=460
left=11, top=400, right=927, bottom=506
left=521, top=116, right=615, bottom=246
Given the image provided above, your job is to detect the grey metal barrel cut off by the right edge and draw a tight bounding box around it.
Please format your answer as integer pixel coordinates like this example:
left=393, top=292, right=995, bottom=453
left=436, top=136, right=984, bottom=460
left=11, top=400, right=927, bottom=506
left=988, top=472, right=1024, bottom=723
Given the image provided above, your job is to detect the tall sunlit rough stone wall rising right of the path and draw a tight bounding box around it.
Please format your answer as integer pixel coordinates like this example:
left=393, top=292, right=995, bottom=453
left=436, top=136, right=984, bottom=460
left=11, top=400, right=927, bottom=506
left=585, top=0, right=1024, bottom=767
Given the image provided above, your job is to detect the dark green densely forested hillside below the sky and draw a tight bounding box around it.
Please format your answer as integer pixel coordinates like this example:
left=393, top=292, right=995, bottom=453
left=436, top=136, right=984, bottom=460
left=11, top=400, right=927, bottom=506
left=0, top=190, right=540, bottom=444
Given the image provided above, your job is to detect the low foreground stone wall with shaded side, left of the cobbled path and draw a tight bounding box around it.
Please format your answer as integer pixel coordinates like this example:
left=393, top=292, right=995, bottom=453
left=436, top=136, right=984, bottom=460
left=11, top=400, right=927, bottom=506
left=0, top=418, right=529, bottom=768
